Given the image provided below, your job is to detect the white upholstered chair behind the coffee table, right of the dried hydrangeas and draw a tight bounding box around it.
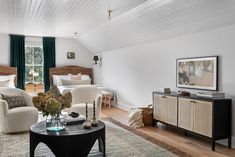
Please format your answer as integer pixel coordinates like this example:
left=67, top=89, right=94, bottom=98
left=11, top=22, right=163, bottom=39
left=66, top=85, right=102, bottom=119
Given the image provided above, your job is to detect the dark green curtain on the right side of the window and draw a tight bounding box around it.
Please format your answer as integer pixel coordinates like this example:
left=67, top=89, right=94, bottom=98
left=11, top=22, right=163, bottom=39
left=42, top=37, right=55, bottom=92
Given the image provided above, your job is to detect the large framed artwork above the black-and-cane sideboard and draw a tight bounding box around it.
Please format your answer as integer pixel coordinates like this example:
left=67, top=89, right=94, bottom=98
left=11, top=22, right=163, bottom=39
left=176, top=56, right=218, bottom=91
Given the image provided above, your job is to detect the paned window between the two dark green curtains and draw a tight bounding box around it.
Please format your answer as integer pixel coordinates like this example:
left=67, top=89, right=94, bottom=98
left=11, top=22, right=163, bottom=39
left=25, top=45, right=43, bottom=84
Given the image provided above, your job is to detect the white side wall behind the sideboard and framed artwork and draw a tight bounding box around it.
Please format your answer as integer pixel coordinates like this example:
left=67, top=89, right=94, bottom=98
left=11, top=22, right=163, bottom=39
left=94, top=25, right=235, bottom=147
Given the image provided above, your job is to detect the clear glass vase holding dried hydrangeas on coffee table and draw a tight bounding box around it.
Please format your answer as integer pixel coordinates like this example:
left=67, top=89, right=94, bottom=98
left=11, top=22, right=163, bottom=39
left=46, top=115, right=65, bottom=132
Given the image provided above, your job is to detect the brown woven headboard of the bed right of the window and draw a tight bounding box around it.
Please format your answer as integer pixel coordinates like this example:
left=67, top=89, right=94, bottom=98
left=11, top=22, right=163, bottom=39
left=49, top=66, right=93, bottom=85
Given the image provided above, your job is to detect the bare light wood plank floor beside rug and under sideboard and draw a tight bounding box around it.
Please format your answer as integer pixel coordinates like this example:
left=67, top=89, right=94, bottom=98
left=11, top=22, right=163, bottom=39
left=101, top=107, right=235, bottom=157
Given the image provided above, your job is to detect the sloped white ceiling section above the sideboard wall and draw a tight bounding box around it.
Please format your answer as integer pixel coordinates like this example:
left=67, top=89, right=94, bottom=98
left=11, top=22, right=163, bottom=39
left=79, top=0, right=235, bottom=53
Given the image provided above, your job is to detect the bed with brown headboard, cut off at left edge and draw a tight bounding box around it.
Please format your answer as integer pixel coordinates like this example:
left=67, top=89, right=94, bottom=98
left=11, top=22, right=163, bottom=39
left=0, top=65, right=17, bottom=88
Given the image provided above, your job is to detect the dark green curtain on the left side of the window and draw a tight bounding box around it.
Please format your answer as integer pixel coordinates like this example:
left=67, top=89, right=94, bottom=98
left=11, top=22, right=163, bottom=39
left=10, top=35, right=25, bottom=89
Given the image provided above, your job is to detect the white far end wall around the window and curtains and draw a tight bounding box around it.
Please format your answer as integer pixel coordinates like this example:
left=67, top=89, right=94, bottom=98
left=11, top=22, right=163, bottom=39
left=0, top=34, right=92, bottom=67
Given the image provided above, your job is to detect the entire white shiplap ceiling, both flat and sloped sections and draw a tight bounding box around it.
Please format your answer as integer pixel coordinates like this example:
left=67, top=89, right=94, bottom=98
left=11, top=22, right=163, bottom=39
left=0, top=0, right=235, bottom=53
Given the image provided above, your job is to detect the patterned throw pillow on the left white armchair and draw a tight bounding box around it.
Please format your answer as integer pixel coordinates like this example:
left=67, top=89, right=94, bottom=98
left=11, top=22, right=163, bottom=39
left=1, top=94, right=26, bottom=109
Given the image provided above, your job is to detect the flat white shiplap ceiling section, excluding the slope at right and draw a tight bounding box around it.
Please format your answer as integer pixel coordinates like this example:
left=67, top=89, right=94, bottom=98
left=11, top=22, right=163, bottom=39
left=0, top=0, right=147, bottom=37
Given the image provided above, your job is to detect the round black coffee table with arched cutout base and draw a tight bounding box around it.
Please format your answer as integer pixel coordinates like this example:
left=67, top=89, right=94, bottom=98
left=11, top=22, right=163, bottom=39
left=30, top=121, right=105, bottom=157
